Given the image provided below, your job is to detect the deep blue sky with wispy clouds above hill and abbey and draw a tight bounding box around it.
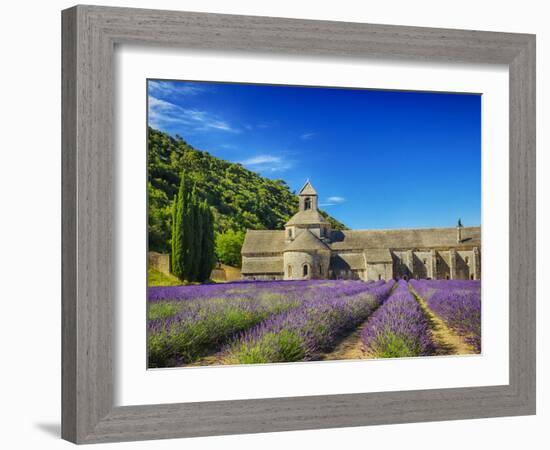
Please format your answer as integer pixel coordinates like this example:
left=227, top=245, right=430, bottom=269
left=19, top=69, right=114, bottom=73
left=148, top=80, right=481, bottom=229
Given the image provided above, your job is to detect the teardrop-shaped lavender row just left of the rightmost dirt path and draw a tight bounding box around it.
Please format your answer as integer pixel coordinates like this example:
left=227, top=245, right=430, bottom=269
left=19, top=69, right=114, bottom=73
left=361, top=280, right=434, bottom=358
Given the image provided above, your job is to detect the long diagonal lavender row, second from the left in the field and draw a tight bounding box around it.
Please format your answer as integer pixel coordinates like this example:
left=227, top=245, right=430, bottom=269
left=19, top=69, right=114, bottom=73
left=225, top=281, right=394, bottom=364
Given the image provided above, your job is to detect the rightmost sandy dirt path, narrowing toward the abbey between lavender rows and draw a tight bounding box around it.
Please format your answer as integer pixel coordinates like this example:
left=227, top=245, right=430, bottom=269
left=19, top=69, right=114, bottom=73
left=411, top=288, right=477, bottom=355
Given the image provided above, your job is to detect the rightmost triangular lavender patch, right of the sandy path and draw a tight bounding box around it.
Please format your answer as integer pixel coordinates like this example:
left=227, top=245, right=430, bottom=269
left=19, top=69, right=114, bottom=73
left=411, top=280, right=481, bottom=353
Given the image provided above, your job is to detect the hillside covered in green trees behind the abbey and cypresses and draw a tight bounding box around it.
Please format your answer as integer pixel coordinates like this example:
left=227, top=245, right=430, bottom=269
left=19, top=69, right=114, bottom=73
left=147, top=128, right=345, bottom=265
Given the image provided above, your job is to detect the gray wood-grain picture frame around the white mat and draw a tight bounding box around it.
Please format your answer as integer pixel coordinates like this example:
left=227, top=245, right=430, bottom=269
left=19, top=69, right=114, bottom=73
left=62, top=6, right=535, bottom=443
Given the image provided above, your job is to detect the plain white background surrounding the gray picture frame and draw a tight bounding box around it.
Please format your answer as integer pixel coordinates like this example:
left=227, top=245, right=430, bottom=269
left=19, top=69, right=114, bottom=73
left=0, top=0, right=550, bottom=450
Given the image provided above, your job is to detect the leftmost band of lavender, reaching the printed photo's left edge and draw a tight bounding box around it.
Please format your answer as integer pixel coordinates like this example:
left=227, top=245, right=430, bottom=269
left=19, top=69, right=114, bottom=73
left=148, top=281, right=386, bottom=367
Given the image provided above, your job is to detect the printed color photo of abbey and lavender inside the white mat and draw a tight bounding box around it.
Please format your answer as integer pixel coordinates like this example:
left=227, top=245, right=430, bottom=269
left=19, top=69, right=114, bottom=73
left=143, top=79, right=482, bottom=369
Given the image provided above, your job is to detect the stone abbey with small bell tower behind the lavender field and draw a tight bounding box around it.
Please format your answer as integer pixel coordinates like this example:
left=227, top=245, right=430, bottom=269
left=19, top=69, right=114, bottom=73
left=241, top=181, right=481, bottom=281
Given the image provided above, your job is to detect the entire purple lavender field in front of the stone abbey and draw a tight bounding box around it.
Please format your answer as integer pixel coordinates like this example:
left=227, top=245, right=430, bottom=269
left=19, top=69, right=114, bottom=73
left=148, top=280, right=481, bottom=368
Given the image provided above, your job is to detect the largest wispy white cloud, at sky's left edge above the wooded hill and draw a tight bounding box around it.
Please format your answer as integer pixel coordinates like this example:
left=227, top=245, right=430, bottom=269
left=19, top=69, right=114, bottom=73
left=149, top=95, right=240, bottom=133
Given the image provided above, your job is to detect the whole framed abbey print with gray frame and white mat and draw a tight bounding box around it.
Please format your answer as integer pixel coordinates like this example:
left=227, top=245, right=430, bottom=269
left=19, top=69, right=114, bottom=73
left=62, top=6, right=535, bottom=443
